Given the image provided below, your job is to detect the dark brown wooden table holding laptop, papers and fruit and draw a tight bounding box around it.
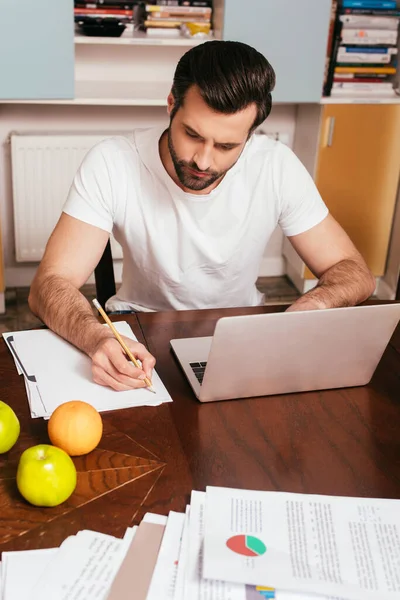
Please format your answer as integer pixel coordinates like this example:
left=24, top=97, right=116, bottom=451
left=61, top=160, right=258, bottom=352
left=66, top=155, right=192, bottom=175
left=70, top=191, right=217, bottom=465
left=0, top=307, right=400, bottom=551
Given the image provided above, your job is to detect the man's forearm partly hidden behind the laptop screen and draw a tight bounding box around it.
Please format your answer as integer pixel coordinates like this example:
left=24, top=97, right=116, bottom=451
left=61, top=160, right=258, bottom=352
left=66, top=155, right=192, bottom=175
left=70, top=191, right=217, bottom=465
left=290, top=259, right=375, bottom=310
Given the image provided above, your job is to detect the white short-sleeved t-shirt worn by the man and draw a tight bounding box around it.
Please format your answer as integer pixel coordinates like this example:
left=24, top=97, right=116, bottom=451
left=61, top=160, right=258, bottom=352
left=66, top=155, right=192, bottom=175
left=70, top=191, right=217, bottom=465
left=64, top=128, right=328, bottom=310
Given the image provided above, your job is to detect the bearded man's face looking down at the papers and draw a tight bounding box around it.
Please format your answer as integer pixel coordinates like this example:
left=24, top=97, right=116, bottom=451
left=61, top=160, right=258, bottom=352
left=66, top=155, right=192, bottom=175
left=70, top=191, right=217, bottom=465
left=168, top=86, right=256, bottom=193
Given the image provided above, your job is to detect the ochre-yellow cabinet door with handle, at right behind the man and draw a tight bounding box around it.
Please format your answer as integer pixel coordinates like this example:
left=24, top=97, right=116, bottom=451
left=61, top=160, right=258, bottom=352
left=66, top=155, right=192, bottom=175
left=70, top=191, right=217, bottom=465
left=316, top=104, right=400, bottom=276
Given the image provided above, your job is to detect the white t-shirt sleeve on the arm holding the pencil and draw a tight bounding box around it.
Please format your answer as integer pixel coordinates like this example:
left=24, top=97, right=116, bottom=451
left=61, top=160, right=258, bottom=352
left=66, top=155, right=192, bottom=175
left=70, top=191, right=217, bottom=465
left=63, top=140, right=115, bottom=233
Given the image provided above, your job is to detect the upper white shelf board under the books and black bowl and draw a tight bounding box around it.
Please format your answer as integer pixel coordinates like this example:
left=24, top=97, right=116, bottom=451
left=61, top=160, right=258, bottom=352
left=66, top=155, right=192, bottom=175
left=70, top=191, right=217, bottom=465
left=75, top=29, right=209, bottom=48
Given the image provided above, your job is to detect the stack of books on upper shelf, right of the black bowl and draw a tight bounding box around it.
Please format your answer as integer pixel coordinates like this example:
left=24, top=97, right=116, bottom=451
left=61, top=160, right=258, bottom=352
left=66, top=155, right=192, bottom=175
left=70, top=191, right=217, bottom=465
left=135, top=0, right=212, bottom=35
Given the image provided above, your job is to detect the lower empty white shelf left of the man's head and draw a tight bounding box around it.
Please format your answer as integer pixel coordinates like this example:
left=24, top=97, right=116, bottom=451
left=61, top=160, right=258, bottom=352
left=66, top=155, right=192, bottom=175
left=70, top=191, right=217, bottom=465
left=0, top=81, right=171, bottom=106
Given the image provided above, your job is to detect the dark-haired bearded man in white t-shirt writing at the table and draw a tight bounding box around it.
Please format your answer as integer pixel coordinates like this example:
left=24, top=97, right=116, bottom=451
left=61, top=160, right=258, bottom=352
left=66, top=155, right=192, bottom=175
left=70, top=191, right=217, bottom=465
left=29, top=42, right=374, bottom=390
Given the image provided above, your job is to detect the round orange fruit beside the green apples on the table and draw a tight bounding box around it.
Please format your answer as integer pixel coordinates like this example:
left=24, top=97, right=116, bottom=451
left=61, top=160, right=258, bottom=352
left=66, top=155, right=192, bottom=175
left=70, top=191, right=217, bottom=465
left=47, top=400, right=103, bottom=456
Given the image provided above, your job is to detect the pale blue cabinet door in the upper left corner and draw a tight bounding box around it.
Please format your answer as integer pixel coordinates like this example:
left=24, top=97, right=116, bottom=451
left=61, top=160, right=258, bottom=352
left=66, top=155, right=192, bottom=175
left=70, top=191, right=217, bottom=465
left=0, top=0, right=74, bottom=100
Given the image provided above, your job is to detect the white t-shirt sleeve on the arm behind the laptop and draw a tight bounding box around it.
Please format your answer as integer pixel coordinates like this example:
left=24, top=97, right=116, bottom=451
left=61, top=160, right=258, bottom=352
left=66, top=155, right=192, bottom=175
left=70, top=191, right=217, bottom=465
left=275, top=145, right=329, bottom=236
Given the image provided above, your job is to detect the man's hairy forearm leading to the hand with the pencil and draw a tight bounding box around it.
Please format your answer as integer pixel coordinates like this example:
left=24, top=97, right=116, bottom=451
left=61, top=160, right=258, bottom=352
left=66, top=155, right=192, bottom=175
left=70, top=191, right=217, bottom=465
left=29, top=275, right=112, bottom=356
